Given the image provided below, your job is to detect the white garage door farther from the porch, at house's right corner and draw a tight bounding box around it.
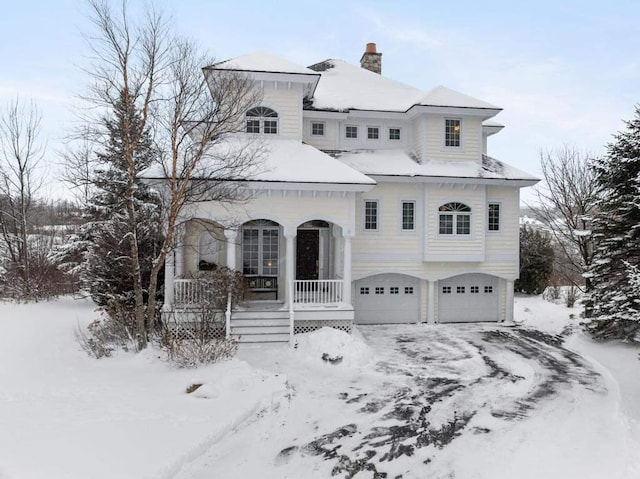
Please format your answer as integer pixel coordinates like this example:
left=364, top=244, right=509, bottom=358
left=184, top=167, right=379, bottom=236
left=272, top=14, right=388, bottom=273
left=438, top=273, right=500, bottom=323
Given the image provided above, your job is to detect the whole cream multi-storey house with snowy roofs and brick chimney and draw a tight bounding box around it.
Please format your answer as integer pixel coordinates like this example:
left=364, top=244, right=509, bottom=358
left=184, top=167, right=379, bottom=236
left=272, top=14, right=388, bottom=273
left=159, top=43, right=538, bottom=341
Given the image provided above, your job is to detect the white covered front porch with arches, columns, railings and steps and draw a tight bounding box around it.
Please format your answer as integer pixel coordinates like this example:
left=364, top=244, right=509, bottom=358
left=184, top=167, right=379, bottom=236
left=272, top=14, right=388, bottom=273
left=164, top=217, right=354, bottom=342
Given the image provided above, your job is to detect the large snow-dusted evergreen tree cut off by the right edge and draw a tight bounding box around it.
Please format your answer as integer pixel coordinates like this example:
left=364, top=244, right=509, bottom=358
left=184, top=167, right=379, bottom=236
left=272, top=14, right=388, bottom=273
left=587, top=107, right=640, bottom=340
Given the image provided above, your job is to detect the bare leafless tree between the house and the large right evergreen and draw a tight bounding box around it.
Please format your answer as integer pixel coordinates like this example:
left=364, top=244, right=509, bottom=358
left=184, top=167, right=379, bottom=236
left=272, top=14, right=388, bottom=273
left=529, top=145, right=600, bottom=314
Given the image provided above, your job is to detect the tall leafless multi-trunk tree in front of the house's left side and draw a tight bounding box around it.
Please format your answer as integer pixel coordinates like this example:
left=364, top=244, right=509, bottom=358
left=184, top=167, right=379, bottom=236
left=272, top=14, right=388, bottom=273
left=75, top=0, right=259, bottom=344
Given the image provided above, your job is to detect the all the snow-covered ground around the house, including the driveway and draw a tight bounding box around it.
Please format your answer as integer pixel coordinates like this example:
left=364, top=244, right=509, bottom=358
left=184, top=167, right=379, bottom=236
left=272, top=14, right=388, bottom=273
left=0, top=297, right=640, bottom=479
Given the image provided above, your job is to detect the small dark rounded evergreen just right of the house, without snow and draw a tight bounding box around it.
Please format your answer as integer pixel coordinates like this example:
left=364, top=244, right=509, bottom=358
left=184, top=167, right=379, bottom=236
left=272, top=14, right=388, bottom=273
left=514, top=226, right=554, bottom=294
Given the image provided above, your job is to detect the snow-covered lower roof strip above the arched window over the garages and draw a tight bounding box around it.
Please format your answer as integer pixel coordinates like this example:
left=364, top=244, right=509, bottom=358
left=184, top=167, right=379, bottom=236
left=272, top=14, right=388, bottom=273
left=335, top=150, right=538, bottom=182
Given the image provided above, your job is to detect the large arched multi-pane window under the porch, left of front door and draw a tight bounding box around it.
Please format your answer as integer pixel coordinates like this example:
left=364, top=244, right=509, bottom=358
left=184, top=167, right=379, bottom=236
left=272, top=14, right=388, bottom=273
left=242, top=220, right=279, bottom=276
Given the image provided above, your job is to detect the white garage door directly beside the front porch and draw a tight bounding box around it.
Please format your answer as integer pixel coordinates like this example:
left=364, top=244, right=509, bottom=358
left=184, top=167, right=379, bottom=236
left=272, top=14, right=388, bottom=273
left=355, top=273, right=420, bottom=324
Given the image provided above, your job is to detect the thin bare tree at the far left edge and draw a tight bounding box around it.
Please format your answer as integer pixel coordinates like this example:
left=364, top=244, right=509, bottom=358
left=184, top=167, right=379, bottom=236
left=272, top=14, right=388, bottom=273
left=0, top=98, right=45, bottom=297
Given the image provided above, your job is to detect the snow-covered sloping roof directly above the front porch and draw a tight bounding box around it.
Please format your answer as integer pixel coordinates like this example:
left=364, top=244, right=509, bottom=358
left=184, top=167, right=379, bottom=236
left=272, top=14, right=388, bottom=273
left=142, top=136, right=376, bottom=186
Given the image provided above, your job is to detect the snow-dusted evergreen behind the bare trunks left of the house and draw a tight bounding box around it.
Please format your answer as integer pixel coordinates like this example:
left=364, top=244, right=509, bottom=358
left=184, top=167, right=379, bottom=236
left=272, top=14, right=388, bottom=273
left=57, top=90, right=163, bottom=316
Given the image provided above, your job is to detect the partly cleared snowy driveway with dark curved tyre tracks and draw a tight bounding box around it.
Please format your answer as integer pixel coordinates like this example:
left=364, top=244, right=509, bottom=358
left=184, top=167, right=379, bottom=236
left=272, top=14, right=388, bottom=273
left=177, top=325, right=634, bottom=479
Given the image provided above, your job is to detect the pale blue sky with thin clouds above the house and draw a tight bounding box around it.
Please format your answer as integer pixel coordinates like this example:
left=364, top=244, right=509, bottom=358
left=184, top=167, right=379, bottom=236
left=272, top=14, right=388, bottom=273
left=0, top=0, right=640, bottom=202
